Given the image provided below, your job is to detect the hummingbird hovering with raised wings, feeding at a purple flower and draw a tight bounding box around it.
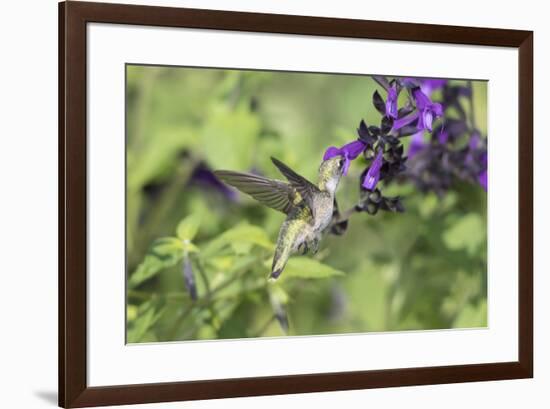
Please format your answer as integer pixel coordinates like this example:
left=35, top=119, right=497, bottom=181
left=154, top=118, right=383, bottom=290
left=214, top=156, right=345, bottom=280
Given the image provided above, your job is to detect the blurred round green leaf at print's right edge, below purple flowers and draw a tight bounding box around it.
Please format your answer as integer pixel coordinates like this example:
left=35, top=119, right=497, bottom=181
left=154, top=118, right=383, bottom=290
left=443, top=213, right=487, bottom=255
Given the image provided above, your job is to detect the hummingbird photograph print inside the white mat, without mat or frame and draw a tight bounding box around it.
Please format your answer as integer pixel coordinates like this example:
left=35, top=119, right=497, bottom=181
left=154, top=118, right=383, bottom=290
left=126, top=64, right=490, bottom=343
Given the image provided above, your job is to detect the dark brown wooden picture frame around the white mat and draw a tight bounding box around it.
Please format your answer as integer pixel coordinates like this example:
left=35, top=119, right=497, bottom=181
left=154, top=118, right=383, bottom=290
left=59, top=2, right=533, bottom=407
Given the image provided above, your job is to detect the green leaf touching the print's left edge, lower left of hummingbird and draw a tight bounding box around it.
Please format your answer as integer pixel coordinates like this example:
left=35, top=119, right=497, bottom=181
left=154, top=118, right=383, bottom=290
left=128, top=237, right=183, bottom=288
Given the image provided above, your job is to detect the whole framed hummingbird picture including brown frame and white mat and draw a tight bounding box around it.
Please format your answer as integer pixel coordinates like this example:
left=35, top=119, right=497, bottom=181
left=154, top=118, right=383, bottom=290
left=57, top=1, right=534, bottom=407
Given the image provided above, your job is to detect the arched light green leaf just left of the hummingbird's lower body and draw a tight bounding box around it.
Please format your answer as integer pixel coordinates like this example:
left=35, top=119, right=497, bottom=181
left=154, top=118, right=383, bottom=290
left=203, top=223, right=273, bottom=257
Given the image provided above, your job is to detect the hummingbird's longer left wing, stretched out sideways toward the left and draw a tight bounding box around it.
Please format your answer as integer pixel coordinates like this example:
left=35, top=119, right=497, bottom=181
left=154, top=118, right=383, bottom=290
left=214, top=170, right=301, bottom=214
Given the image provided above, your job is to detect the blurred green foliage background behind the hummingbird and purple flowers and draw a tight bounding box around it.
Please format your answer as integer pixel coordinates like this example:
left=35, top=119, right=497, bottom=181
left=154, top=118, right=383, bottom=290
left=126, top=65, right=487, bottom=343
